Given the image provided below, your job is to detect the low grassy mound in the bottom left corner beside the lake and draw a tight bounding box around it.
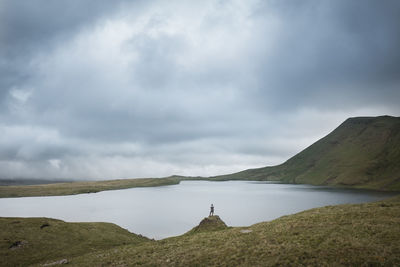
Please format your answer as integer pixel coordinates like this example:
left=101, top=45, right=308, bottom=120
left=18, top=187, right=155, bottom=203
left=0, top=218, right=151, bottom=266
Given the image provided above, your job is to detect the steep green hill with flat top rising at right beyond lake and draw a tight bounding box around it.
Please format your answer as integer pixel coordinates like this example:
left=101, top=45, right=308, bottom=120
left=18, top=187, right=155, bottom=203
left=210, top=116, right=400, bottom=191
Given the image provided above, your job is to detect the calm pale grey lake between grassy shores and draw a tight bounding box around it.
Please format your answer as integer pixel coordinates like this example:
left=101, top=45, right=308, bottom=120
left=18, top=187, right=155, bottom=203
left=0, top=181, right=394, bottom=239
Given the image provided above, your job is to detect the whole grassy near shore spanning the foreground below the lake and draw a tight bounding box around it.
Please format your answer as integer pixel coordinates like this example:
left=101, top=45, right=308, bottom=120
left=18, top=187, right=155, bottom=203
left=0, top=196, right=400, bottom=266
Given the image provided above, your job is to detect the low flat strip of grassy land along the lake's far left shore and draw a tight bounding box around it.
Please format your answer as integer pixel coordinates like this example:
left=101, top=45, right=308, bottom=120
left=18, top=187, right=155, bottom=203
left=0, top=176, right=184, bottom=198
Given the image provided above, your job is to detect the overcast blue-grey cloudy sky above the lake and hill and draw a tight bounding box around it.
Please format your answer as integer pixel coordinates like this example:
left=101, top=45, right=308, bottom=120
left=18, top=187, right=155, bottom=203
left=0, top=0, right=400, bottom=180
